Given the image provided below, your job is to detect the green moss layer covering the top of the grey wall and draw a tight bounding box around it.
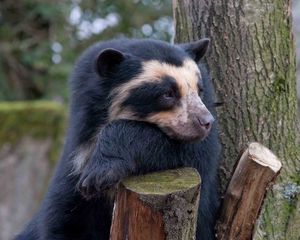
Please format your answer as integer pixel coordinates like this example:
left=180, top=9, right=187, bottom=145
left=0, top=101, right=66, bottom=164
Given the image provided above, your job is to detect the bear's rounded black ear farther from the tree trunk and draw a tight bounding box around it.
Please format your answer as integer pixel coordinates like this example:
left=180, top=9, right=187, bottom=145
left=96, top=48, right=125, bottom=77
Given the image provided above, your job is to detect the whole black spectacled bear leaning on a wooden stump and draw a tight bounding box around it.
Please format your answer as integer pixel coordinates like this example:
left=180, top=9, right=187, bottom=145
left=16, top=39, right=220, bottom=240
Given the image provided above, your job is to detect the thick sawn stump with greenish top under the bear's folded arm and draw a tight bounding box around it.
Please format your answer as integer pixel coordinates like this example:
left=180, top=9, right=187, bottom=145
left=110, top=168, right=200, bottom=240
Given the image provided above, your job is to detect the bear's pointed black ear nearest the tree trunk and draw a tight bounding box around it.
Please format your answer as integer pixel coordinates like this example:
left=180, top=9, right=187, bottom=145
left=179, top=38, right=210, bottom=62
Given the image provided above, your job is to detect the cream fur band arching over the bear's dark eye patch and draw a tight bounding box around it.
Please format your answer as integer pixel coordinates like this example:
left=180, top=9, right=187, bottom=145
left=109, top=59, right=201, bottom=120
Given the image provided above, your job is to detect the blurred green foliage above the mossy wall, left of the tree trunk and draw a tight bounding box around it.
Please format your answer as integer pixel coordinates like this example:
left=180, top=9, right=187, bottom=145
left=0, top=0, right=173, bottom=102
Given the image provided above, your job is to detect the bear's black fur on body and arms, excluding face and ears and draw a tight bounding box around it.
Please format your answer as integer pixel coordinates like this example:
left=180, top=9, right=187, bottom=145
left=16, top=39, right=220, bottom=240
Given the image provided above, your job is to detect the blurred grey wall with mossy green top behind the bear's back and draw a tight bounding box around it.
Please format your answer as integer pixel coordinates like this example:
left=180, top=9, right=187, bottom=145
left=0, top=101, right=66, bottom=240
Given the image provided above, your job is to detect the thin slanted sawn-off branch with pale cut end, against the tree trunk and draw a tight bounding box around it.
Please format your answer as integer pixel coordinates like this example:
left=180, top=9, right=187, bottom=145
left=217, top=143, right=281, bottom=240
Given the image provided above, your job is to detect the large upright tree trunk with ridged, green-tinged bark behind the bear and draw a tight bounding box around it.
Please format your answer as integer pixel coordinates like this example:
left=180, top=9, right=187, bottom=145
left=173, top=0, right=300, bottom=239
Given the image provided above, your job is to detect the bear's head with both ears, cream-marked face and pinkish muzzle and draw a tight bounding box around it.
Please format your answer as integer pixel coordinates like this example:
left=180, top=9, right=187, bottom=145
left=96, top=39, right=214, bottom=141
